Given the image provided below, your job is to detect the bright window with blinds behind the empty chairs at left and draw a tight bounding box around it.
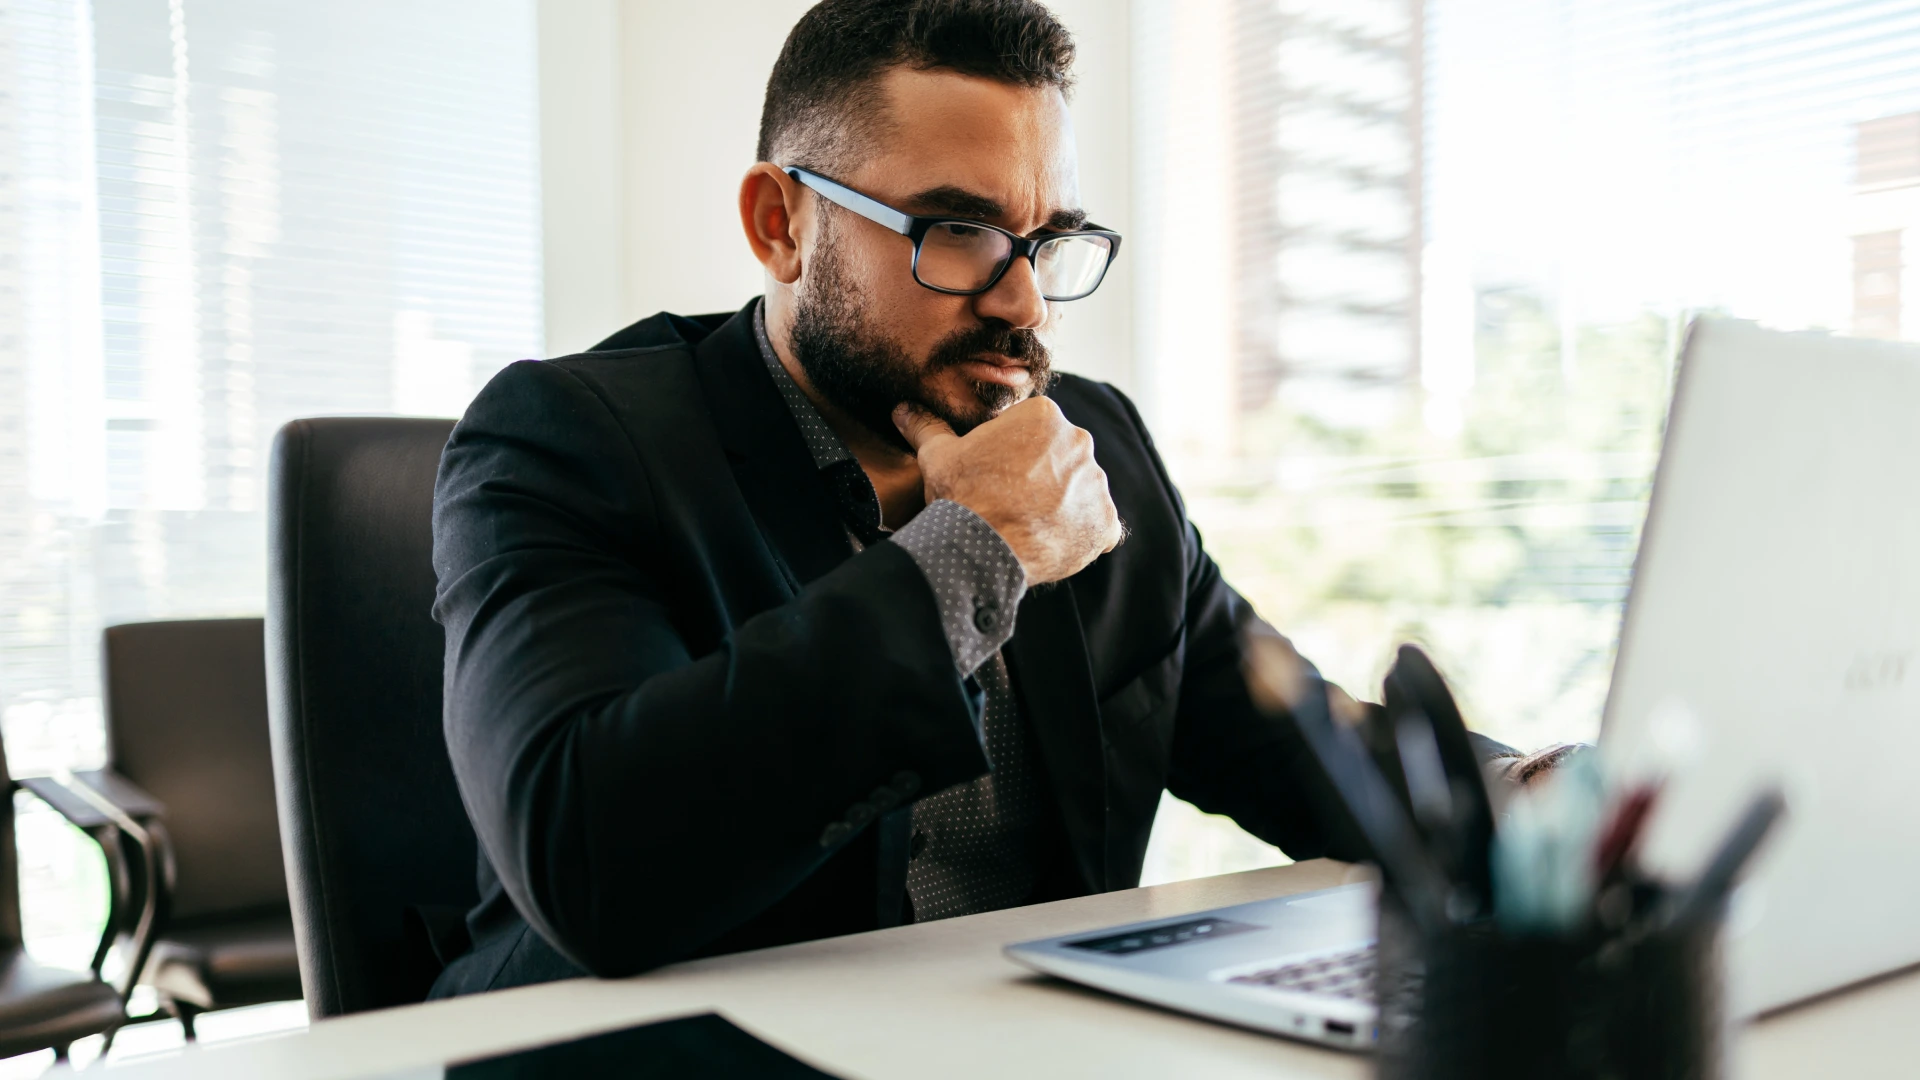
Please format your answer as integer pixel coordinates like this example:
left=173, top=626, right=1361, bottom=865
left=0, top=0, right=541, bottom=961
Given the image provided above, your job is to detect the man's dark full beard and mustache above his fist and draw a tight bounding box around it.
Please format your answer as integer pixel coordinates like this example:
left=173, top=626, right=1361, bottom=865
left=793, top=215, right=1054, bottom=454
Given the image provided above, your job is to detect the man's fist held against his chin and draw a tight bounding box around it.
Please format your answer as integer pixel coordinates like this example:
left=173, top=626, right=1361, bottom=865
left=893, top=398, right=1121, bottom=584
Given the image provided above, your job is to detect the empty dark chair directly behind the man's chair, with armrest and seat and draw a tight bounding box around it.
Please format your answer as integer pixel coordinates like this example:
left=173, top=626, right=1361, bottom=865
left=75, top=619, right=300, bottom=1040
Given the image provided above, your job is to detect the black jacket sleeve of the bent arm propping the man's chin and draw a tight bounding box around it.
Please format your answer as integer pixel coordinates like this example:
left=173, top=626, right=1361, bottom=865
left=434, top=361, right=987, bottom=976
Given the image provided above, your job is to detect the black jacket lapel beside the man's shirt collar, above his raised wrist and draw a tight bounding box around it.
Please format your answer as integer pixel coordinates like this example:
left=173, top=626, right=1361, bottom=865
left=695, top=300, right=852, bottom=592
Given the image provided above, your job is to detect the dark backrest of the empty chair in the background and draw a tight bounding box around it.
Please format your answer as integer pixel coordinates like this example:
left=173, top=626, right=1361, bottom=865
left=100, top=619, right=286, bottom=924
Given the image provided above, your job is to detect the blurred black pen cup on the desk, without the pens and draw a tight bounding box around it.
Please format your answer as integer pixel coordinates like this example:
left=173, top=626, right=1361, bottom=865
left=1375, top=886, right=1726, bottom=1080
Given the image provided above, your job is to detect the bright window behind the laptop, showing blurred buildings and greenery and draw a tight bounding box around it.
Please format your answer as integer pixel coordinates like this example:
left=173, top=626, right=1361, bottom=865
left=1135, top=0, right=1920, bottom=880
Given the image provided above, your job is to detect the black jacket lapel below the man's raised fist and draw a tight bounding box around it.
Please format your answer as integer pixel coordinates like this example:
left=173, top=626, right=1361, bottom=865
left=1006, top=582, right=1114, bottom=890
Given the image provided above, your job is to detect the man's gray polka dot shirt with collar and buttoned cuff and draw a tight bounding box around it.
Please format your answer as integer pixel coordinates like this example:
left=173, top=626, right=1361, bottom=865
left=753, top=302, right=1041, bottom=922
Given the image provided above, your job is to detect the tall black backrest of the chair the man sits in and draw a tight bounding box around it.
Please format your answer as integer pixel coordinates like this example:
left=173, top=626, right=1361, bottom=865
left=267, top=417, right=476, bottom=1019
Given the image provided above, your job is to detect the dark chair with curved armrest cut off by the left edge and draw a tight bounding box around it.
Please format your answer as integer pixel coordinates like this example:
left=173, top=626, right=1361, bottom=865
left=0, top=734, right=137, bottom=1061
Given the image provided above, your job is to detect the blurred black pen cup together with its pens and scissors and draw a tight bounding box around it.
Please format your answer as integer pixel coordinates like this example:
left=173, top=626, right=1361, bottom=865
left=1246, top=636, right=1786, bottom=1080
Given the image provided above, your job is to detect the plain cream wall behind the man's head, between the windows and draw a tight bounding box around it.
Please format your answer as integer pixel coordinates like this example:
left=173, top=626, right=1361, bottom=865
left=540, top=0, right=1135, bottom=388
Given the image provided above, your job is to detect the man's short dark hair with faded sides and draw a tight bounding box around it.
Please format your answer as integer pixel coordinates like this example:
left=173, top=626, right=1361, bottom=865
left=758, top=0, right=1073, bottom=167
